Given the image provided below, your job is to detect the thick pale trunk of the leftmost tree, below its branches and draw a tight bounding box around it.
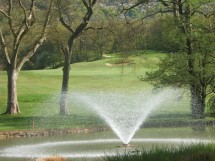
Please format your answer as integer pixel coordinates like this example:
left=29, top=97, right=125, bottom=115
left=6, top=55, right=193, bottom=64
left=5, top=69, right=20, bottom=114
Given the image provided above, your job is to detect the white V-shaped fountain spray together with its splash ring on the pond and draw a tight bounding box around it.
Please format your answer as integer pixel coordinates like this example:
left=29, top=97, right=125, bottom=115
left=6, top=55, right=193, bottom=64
left=0, top=90, right=211, bottom=161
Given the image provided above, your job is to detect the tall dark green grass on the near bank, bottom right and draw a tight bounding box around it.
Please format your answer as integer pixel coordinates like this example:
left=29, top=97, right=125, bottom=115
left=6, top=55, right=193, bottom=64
left=101, top=144, right=215, bottom=161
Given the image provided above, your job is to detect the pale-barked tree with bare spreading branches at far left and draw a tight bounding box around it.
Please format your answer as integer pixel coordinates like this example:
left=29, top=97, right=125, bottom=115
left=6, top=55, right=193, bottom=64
left=0, top=0, right=53, bottom=114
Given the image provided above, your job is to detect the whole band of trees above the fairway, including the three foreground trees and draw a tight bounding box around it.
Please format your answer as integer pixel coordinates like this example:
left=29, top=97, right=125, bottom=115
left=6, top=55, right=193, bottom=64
left=0, top=0, right=215, bottom=118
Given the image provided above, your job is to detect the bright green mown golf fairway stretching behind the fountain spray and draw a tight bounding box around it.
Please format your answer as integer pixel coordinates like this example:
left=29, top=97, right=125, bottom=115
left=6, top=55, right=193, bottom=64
left=0, top=51, right=214, bottom=130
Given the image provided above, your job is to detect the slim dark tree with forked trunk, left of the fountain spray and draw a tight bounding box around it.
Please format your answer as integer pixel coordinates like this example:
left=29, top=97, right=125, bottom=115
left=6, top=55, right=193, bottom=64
left=57, top=0, right=97, bottom=115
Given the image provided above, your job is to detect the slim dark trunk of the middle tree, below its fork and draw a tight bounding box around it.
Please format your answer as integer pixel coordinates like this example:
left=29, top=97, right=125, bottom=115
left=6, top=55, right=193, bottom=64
left=60, top=48, right=72, bottom=115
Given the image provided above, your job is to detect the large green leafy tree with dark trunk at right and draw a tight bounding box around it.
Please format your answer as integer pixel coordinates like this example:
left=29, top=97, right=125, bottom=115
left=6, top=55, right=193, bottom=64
left=127, top=0, right=215, bottom=118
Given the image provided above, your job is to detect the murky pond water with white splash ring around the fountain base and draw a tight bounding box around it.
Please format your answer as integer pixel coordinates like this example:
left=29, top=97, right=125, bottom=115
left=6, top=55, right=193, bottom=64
left=0, top=126, right=215, bottom=161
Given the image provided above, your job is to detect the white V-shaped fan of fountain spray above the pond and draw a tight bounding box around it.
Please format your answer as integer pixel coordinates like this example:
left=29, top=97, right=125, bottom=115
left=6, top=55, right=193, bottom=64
left=70, top=90, right=175, bottom=145
